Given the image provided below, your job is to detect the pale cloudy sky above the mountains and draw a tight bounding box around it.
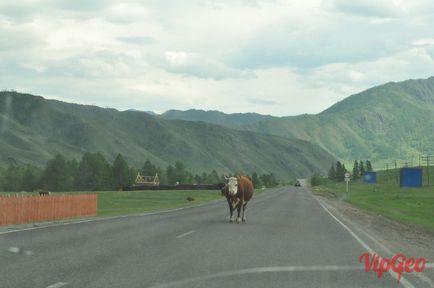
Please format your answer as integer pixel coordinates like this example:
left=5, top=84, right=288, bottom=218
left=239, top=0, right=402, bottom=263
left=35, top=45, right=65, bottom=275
left=0, top=0, right=434, bottom=116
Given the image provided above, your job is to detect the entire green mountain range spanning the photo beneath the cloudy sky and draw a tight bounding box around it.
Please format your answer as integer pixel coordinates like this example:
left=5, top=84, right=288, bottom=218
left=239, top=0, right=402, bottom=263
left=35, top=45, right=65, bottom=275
left=0, top=77, right=434, bottom=179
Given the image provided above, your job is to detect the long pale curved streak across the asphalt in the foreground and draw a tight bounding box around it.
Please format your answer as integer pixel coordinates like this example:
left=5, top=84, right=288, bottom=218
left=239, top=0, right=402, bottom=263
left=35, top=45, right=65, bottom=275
left=152, top=265, right=363, bottom=288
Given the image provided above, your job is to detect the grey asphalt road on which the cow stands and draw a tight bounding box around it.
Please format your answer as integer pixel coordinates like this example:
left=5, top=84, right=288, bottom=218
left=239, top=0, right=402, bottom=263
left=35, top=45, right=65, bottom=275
left=0, top=187, right=427, bottom=288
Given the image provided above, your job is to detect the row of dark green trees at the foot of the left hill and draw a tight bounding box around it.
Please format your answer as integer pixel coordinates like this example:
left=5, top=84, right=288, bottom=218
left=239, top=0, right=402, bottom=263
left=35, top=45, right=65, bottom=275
left=0, top=152, right=278, bottom=192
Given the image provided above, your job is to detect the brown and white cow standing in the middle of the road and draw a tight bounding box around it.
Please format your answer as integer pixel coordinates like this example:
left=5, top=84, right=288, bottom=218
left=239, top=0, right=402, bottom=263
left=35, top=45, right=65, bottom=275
left=221, top=176, right=253, bottom=222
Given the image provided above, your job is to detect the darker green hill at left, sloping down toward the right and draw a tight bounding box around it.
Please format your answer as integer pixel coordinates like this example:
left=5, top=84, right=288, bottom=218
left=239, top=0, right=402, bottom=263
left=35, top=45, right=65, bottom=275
left=0, top=92, right=334, bottom=180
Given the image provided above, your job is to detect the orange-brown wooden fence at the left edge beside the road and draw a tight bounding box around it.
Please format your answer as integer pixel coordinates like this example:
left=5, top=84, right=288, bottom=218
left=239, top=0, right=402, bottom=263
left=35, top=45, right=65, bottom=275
left=0, top=194, right=98, bottom=226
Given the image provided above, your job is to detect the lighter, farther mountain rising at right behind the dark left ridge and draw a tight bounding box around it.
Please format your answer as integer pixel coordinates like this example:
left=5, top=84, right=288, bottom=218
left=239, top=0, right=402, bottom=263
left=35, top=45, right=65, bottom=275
left=161, top=77, right=434, bottom=164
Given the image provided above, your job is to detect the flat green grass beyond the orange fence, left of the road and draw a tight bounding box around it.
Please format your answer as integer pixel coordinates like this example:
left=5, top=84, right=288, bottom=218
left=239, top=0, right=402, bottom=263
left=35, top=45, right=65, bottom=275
left=0, top=189, right=270, bottom=216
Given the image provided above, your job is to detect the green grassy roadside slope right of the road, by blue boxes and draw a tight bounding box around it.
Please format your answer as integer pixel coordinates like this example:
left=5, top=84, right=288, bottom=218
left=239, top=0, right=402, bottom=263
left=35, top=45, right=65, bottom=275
left=313, top=168, right=434, bottom=231
